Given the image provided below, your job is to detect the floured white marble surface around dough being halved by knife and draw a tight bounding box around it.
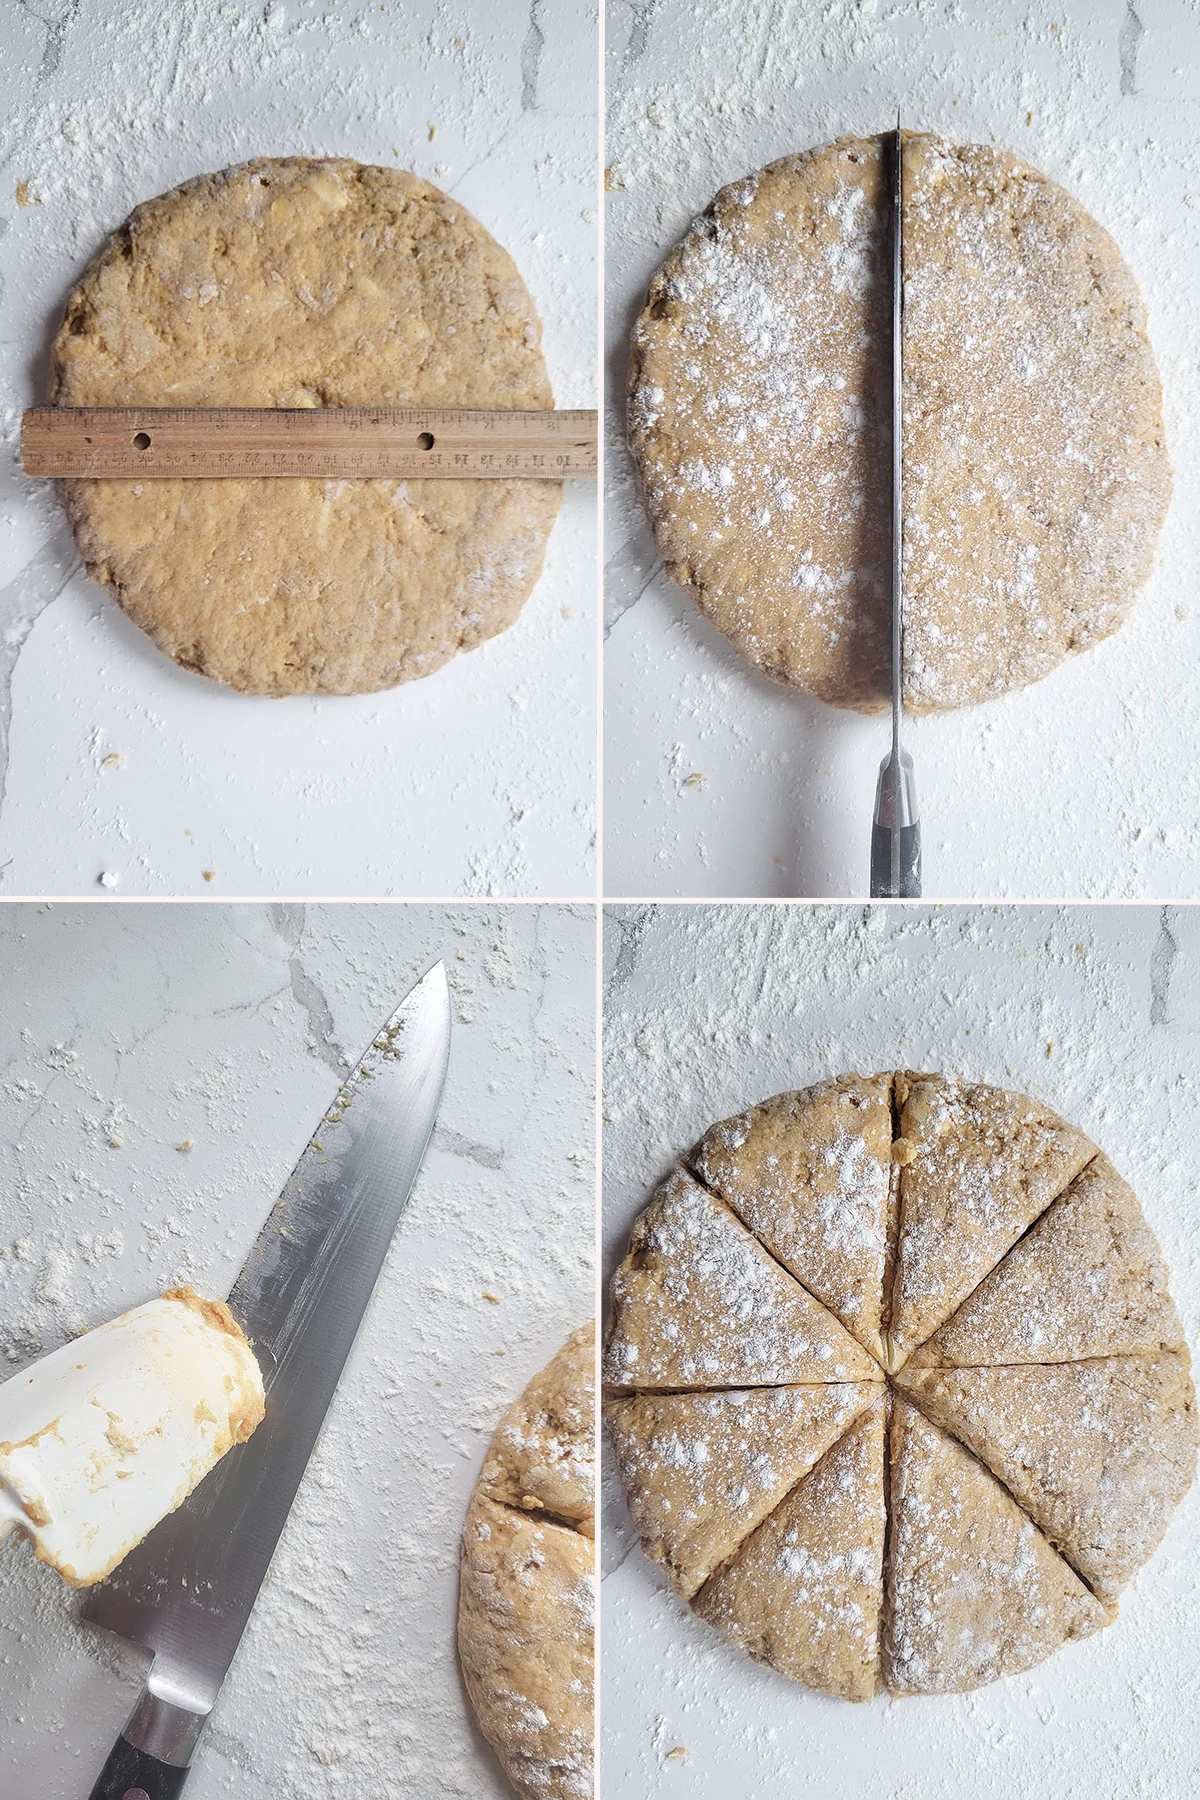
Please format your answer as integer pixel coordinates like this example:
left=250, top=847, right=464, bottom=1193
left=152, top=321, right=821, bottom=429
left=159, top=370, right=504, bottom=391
left=604, top=0, right=1200, bottom=898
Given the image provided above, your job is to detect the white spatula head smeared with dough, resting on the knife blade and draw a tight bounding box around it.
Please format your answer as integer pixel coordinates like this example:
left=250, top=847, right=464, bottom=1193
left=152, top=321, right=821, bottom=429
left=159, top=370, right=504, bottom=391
left=0, top=1287, right=264, bottom=1588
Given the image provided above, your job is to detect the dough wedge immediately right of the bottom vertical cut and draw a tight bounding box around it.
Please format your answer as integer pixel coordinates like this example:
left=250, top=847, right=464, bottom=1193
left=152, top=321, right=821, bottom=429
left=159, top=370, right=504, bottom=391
left=883, top=1395, right=1110, bottom=1694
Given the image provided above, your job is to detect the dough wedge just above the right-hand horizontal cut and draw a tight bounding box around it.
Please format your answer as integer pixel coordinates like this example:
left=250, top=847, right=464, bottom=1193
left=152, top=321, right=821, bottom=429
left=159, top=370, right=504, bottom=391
left=909, top=1156, right=1186, bottom=1368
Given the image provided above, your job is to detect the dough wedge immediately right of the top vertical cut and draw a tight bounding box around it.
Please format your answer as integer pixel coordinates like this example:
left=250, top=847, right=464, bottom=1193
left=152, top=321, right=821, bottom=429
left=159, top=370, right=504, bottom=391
left=889, top=1075, right=1096, bottom=1368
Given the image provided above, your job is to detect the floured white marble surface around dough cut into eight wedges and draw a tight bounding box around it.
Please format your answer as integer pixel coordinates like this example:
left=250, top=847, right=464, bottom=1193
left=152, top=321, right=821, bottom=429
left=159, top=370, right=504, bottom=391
left=601, top=905, right=1200, bottom=1800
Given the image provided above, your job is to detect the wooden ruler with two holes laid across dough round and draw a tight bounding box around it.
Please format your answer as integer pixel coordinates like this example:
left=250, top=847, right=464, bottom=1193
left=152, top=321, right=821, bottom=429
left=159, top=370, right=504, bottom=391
left=22, top=407, right=596, bottom=481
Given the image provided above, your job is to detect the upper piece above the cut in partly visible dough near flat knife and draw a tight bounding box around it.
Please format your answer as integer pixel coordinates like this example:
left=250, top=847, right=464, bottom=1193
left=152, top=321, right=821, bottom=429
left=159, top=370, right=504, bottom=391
left=479, top=1319, right=596, bottom=1537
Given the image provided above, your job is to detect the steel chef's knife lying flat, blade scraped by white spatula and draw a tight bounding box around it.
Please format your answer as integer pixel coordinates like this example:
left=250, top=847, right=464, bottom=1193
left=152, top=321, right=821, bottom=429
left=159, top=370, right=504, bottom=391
left=83, top=963, right=450, bottom=1800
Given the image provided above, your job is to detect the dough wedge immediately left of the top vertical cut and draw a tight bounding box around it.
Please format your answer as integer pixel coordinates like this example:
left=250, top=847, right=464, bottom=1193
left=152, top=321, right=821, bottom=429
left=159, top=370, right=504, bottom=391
left=687, top=1075, right=892, bottom=1361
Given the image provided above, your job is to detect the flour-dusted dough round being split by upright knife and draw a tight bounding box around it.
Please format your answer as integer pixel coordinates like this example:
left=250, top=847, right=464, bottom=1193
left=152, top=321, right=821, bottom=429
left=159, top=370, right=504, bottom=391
left=630, top=133, right=1171, bottom=713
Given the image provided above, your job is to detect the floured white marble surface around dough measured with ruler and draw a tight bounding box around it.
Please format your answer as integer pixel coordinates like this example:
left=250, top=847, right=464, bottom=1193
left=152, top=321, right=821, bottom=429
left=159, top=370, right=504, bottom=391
left=0, top=0, right=599, bottom=896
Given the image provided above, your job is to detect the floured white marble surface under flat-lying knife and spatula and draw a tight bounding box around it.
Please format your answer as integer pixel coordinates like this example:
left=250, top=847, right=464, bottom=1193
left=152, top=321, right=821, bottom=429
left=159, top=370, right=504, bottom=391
left=0, top=904, right=596, bottom=1800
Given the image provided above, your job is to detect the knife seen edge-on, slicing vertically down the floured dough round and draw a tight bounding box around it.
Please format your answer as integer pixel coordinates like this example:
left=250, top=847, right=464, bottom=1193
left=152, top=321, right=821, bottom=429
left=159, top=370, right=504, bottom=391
left=871, top=113, right=921, bottom=900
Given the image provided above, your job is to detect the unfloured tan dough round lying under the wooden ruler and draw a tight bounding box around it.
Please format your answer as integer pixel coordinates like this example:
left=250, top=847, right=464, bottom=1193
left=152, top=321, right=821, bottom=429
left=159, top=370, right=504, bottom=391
left=49, top=157, right=561, bottom=695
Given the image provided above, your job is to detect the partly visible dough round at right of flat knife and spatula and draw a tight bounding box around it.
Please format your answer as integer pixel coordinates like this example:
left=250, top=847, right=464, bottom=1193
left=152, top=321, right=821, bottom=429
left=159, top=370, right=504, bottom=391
left=459, top=1325, right=596, bottom=1800
